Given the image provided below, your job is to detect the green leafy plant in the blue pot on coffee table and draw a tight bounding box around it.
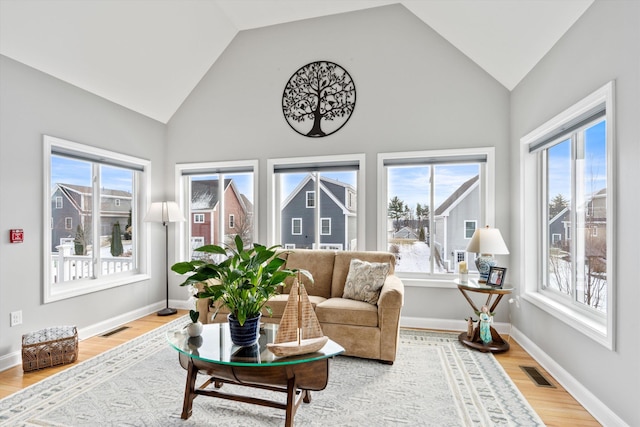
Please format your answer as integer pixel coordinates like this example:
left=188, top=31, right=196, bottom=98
left=171, top=236, right=313, bottom=325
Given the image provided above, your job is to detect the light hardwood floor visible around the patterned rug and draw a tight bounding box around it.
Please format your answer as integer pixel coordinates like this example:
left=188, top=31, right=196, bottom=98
left=0, top=310, right=600, bottom=427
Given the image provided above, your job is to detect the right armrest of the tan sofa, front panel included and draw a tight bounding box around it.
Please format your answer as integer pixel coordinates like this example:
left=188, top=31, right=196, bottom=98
left=378, top=274, right=404, bottom=363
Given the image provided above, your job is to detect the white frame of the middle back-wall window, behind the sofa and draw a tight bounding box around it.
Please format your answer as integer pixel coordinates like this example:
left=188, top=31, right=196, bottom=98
left=267, top=153, right=366, bottom=250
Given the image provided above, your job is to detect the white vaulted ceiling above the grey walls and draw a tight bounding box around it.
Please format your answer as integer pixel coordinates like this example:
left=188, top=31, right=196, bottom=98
left=0, top=0, right=594, bottom=123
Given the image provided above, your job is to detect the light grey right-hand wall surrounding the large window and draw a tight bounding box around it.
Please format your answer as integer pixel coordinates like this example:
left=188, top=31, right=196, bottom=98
left=510, top=0, right=640, bottom=426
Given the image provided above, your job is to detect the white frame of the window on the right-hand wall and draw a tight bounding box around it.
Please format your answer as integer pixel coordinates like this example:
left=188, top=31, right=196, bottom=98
left=520, top=81, right=616, bottom=350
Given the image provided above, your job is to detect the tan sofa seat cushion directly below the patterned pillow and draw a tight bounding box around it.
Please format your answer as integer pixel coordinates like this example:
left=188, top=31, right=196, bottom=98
left=316, top=298, right=378, bottom=327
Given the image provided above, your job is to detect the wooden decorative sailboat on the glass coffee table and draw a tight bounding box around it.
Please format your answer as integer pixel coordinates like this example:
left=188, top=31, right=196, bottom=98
left=267, top=274, right=328, bottom=356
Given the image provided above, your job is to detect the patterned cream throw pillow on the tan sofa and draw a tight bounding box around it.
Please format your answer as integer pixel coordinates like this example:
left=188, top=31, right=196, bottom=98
left=342, top=258, right=390, bottom=304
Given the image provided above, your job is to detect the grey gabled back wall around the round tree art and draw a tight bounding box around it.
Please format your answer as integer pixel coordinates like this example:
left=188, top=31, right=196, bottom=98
left=165, top=5, right=510, bottom=327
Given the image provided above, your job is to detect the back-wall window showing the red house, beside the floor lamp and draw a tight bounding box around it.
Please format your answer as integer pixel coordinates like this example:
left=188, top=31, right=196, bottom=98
left=176, top=160, right=258, bottom=259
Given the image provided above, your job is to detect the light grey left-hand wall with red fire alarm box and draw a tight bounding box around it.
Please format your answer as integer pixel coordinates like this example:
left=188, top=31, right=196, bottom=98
left=0, top=56, right=165, bottom=369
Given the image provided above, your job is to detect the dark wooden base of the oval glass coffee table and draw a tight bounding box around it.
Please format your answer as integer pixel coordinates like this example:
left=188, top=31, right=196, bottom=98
left=179, top=353, right=329, bottom=427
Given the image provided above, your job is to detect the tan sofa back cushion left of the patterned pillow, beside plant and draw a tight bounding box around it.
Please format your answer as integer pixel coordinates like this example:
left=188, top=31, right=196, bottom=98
left=283, top=249, right=336, bottom=298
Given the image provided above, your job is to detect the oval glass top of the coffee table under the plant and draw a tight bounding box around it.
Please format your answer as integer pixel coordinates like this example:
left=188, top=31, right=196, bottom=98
left=167, top=323, right=344, bottom=366
